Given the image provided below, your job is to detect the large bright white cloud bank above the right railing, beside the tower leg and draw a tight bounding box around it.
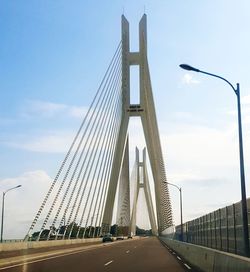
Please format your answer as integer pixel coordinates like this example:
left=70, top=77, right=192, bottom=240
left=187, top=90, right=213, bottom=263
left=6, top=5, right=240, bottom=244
left=158, top=120, right=250, bottom=224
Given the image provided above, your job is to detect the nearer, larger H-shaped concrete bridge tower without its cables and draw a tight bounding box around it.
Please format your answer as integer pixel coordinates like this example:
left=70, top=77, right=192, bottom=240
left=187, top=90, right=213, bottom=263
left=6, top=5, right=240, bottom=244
left=102, top=14, right=173, bottom=233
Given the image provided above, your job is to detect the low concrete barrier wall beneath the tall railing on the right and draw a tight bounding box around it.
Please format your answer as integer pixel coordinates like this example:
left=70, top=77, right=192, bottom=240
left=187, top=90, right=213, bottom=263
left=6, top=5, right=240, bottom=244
left=160, top=237, right=250, bottom=272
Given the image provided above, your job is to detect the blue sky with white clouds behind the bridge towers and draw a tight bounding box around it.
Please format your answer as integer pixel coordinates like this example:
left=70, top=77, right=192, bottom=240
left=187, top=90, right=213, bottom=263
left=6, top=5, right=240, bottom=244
left=0, top=0, right=250, bottom=237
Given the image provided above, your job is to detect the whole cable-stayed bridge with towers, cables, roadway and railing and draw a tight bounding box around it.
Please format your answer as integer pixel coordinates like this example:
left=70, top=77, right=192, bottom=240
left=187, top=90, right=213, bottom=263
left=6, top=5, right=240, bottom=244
left=0, top=14, right=250, bottom=271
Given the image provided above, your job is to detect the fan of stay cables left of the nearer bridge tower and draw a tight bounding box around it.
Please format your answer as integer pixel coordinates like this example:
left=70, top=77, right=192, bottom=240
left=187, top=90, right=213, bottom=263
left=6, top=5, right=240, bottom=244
left=26, top=43, right=122, bottom=241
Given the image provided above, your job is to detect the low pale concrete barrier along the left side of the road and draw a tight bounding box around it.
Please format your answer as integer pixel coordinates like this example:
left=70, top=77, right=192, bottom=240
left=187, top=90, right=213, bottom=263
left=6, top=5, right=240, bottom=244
left=0, top=238, right=101, bottom=251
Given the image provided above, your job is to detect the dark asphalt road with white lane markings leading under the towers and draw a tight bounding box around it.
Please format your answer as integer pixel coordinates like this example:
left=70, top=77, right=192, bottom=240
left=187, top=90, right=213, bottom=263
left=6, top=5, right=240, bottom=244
left=0, top=237, right=195, bottom=272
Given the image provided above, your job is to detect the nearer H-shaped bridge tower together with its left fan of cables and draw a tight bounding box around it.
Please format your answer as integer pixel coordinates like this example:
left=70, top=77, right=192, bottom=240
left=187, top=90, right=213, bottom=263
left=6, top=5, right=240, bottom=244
left=25, top=15, right=173, bottom=241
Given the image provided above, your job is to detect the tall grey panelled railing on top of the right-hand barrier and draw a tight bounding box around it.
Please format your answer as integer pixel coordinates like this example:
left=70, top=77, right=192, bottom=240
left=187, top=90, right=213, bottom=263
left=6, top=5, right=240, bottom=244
left=174, top=198, right=250, bottom=255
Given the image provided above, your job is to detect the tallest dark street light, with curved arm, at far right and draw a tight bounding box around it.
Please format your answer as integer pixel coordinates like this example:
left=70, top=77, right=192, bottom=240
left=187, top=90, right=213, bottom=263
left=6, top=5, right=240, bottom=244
left=180, top=64, right=250, bottom=257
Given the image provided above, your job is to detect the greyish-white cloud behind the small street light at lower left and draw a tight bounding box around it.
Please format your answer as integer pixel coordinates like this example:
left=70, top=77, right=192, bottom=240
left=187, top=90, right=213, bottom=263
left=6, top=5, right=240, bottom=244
left=0, top=170, right=51, bottom=239
